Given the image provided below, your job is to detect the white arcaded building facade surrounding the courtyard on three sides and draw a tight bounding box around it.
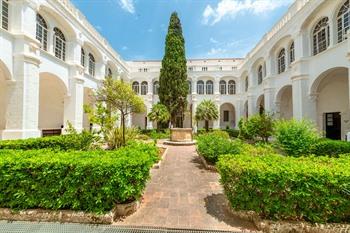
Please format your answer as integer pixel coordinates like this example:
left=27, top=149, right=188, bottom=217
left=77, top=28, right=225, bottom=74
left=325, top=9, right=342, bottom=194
left=0, top=0, right=350, bottom=139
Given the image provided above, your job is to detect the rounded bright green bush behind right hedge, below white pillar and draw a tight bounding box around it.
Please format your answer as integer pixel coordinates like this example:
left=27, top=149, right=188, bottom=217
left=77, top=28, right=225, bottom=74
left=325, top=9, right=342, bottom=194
left=275, top=119, right=318, bottom=157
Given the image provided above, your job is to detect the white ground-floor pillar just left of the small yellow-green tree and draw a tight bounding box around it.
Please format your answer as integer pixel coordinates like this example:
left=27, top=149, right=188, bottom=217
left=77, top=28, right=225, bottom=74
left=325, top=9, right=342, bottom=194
left=64, top=77, right=84, bottom=132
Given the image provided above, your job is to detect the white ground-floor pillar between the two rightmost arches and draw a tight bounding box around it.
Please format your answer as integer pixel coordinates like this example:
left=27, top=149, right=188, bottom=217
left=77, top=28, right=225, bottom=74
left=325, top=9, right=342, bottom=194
left=292, top=75, right=317, bottom=123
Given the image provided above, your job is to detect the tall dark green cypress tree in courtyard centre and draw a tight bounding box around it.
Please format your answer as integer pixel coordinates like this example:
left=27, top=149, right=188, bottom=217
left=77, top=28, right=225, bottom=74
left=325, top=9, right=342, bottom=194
left=159, top=12, right=189, bottom=127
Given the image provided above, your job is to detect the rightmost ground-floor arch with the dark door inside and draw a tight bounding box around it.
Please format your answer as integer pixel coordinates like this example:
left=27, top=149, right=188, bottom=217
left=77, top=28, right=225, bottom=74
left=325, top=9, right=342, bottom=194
left=311, top=67, right=350, bottom=140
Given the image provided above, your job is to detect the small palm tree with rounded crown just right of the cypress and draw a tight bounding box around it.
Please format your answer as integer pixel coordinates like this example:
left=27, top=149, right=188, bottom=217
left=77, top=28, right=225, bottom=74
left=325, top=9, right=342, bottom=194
left=195, top=100, right=219, bottom=132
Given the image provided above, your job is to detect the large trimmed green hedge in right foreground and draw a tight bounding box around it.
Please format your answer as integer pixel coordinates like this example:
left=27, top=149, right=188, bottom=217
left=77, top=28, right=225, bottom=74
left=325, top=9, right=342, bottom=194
left=217, top=154, right=350, bottom=222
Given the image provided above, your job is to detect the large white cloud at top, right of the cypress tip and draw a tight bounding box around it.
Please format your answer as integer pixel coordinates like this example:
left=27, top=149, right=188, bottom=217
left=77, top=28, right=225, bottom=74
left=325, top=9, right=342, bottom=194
left=202, top=0, right=293, bottom=25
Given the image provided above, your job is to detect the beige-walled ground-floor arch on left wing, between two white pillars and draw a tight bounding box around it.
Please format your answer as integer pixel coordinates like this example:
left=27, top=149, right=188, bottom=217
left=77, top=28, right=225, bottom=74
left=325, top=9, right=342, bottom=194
left=38, top=73, right=67, bottom=136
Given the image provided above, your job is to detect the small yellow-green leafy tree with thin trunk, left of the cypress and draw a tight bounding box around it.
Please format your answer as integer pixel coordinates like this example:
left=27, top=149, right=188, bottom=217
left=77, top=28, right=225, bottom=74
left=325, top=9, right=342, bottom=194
left=86, top=77, right=145, bottom=145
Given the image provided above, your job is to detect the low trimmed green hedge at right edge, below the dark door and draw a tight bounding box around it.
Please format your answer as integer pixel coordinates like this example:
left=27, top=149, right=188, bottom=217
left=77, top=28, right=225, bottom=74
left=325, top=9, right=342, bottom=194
left=311, top=139, right=350, bottom=157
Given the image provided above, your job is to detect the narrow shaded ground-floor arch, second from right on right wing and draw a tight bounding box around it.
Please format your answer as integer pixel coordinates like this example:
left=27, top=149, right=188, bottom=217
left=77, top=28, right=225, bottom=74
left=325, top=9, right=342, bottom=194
left=276, top=85, right=293, bottom=120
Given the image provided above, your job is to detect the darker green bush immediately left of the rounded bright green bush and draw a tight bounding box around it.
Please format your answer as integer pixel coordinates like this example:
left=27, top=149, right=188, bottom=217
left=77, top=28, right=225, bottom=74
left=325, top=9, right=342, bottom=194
left=239, top=113, right=274, bottom=142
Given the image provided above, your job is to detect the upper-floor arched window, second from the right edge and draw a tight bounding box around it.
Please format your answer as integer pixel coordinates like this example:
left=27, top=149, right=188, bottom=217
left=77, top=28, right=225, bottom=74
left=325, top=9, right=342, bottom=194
left=313, top=17, right=329, bottom=55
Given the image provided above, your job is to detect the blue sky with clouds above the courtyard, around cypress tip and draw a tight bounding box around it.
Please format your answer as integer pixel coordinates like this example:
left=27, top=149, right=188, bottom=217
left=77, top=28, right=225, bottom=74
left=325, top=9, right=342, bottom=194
left=71, top=0, right=293, bottom=60
